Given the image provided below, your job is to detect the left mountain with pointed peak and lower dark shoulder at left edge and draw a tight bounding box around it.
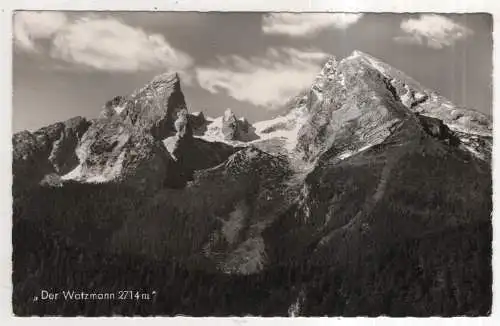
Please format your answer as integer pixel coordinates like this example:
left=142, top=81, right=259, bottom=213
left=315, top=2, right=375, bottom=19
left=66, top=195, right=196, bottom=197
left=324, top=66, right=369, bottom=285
left=13, top=73, right=238, bottom=191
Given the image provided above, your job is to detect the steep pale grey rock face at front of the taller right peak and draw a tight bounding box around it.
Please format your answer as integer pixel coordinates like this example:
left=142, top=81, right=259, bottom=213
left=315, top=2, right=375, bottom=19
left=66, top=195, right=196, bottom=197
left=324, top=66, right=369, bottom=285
left=296, top=55, right=411, bottom=161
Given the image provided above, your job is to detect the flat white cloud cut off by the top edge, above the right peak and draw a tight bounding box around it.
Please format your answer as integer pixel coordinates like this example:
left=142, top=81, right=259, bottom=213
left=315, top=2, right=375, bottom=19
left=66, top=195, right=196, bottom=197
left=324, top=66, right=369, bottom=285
left=262, top=13, right=363, bottom=37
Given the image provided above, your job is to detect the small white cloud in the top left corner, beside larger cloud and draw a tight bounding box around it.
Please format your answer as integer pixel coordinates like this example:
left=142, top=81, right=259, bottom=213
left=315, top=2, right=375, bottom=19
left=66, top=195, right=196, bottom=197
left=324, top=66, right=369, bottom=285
left=14, top=11, right=67, bottom=52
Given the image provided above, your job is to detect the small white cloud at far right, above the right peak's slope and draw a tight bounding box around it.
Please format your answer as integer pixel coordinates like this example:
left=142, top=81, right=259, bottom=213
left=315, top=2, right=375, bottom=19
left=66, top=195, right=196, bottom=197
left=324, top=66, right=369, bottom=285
left=394, top=14, right=474, bottom=49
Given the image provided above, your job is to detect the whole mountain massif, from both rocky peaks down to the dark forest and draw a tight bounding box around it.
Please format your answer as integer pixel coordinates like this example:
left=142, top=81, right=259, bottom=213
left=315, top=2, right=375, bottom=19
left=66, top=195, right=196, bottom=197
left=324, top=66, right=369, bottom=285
left=13, top=51, right=492, bottom=316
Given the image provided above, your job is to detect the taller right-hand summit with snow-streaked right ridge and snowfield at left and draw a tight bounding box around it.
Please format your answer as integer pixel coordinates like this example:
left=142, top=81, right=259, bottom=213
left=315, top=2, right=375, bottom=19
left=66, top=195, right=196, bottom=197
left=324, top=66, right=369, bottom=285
left=255, top=50, right=492, bottom=160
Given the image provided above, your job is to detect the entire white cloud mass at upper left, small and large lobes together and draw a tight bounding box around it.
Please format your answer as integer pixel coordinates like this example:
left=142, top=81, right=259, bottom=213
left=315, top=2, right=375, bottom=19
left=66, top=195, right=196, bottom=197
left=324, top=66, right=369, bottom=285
left=15, top=12, right=193, bottom=72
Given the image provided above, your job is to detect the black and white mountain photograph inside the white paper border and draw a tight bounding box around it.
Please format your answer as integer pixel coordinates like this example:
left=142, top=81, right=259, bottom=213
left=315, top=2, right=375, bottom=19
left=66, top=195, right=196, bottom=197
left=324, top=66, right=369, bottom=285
left=11, top=10, right=493, bottom=317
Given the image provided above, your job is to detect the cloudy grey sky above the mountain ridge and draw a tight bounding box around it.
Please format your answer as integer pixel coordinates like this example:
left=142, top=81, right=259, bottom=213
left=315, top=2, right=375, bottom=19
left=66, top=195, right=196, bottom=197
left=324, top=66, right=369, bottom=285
left=12, top=11, right=493, bottom=132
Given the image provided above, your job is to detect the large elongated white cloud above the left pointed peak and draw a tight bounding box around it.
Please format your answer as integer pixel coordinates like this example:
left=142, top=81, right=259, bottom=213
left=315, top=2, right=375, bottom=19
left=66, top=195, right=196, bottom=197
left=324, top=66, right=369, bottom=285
left=51, top=18, right=192, bottom=71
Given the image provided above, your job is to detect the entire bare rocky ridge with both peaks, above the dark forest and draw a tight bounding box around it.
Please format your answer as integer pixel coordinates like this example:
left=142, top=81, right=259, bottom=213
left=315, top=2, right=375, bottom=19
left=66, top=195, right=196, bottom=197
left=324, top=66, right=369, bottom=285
left=15, top=50, right=492, bottom=192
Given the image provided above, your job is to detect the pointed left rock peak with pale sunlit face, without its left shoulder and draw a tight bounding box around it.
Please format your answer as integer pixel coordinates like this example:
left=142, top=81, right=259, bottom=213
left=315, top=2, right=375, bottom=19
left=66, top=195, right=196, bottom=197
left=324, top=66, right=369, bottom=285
left=56, top=73, right=187, bottom=189
